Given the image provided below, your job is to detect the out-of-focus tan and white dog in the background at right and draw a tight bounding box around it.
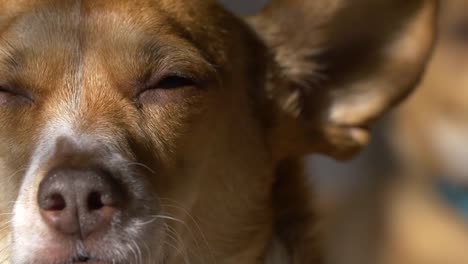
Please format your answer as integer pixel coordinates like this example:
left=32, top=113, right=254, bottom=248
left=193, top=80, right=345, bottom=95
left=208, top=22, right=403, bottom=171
left=331, top=0, right=468, bottom=264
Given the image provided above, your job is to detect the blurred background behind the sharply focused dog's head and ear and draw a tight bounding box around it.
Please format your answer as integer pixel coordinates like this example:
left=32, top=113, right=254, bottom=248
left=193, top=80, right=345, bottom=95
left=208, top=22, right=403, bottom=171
left=221, top=0, right=468, bottom=264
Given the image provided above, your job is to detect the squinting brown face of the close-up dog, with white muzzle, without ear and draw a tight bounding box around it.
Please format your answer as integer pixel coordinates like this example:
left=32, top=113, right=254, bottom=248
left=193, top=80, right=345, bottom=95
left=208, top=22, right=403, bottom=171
left=0, top=1, right=272, bottom=263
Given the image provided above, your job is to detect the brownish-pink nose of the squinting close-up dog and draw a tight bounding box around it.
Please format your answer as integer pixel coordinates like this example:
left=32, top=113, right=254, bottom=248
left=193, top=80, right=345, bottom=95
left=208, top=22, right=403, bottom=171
left=38, top=169, right=124, bottom=239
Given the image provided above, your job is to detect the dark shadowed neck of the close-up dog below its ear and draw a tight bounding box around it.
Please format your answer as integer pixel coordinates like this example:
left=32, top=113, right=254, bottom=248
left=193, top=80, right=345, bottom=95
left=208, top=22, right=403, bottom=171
left=266, top=160, right=321, bottom=264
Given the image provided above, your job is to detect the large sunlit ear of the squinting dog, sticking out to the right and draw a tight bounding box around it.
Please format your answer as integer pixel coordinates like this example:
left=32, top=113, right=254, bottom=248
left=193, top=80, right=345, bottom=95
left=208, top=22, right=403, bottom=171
left=249, top=0, right=437, bottom=159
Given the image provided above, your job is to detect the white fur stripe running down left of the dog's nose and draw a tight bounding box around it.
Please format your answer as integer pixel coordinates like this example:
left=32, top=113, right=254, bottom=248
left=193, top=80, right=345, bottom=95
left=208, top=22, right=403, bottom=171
left=12, top=98, right=91, bottom=263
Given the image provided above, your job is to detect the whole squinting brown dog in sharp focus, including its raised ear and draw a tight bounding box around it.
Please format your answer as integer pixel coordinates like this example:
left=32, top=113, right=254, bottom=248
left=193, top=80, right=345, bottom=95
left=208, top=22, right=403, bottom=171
left=0, top=0, right=436, bottom=264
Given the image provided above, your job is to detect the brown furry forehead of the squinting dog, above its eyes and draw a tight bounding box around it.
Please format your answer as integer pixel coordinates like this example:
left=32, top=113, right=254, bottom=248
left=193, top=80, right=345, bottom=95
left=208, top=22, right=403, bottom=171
left=0, top=0, right=227, bottom=89
